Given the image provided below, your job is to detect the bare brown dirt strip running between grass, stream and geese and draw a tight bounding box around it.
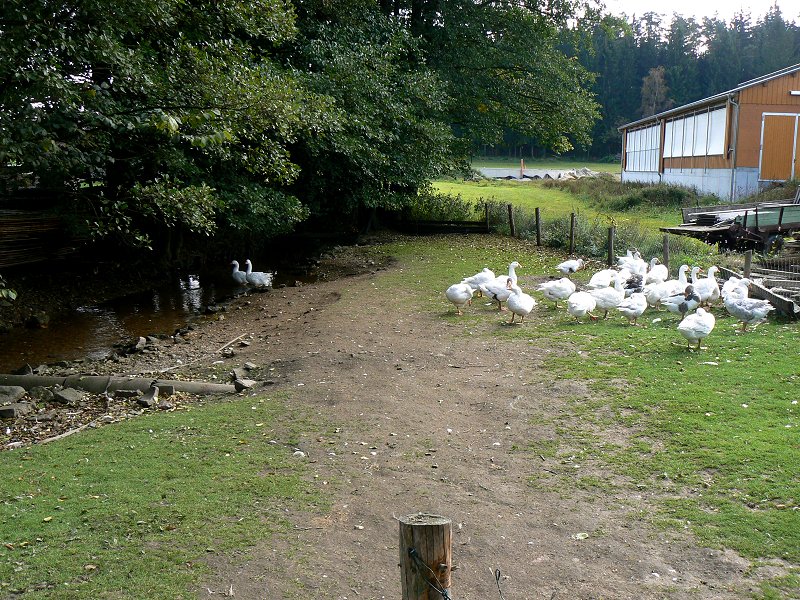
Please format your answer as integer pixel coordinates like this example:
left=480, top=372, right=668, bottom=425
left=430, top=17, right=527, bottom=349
left=0, top=240, right=776, bottom=600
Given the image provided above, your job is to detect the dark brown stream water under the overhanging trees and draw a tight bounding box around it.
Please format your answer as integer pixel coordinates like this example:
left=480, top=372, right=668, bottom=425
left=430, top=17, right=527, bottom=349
left=0, top=274, right=253, bottom=373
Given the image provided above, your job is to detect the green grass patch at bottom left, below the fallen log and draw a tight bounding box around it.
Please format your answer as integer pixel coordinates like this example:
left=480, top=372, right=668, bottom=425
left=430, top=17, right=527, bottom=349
left=0, top=397, right=326, bottom=599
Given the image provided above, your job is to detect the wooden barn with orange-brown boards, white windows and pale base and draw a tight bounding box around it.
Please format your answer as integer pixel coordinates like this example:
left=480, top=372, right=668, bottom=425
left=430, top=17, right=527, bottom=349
left=619, top=64, right=800, bottom=202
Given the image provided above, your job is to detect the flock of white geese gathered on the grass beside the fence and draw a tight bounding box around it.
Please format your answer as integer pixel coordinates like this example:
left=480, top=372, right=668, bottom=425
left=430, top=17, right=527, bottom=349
left=445, top=250, right=775, bottom=349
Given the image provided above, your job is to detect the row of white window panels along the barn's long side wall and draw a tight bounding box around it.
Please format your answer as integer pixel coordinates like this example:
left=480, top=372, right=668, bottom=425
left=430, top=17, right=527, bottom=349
left=625, top=106, right=726, bottom=172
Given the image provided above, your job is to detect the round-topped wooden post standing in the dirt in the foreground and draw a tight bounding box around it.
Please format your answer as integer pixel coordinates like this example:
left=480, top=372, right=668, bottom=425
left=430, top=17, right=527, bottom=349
left=399, top=513, right=453, bottom=600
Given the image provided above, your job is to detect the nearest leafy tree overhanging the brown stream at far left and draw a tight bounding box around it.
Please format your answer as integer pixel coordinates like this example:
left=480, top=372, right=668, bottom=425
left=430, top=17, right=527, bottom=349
left=0, top=0, right=312, bottom=253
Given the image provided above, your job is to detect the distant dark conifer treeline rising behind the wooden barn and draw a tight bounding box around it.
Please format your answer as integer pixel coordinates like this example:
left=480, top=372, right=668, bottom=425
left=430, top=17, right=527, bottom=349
left=484, top=6, right=800, bottom=158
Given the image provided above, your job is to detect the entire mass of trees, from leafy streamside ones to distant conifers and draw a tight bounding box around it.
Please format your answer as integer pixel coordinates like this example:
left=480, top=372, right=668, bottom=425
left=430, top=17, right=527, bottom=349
left=0, top=0, right=800, bottom=261
